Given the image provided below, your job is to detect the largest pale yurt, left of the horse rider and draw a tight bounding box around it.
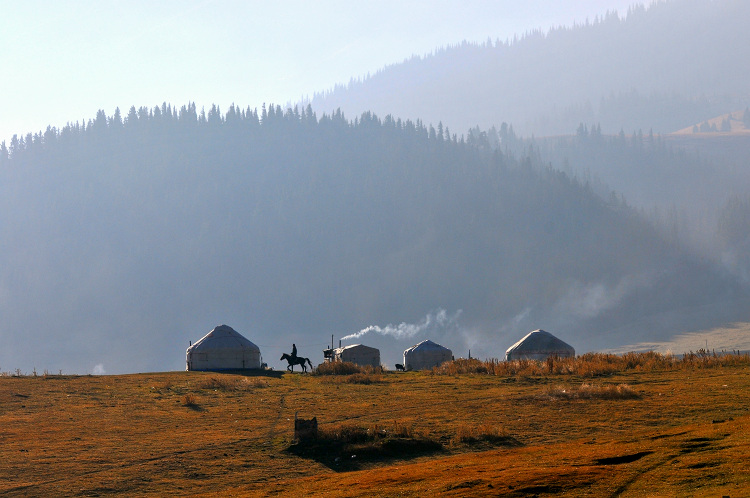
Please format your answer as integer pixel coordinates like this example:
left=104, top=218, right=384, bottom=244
left=186, top=325, right=260, bottom=370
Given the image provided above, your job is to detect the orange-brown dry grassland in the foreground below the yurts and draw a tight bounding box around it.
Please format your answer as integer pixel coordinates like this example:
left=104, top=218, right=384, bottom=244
left=0, top=354, right=750, bottom=496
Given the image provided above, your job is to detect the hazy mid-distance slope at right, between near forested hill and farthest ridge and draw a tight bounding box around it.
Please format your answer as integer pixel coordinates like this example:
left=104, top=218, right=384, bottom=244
left=532, top=121, right=750, bottom=270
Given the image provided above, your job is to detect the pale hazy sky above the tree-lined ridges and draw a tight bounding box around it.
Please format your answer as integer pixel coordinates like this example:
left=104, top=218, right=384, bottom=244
left=0, top=0, right=647, bottom=142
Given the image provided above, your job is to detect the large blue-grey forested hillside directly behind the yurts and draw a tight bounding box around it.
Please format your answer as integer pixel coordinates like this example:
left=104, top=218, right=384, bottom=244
left=0, top=104, right=744, bottom=372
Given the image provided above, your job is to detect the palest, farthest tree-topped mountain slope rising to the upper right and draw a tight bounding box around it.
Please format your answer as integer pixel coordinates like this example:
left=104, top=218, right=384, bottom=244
left=311, top=0, right=750, bottom=136
